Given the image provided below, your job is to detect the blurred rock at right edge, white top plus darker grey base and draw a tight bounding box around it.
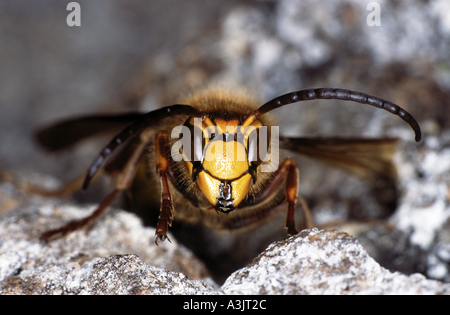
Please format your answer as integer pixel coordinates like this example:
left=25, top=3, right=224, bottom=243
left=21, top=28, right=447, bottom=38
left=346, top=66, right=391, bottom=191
left=358, top=131, right=450, bottom=282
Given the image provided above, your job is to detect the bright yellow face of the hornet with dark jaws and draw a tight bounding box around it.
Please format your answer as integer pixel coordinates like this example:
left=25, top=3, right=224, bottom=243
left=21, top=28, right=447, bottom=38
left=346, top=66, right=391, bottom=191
left=183, top=119, right=260, bottom=213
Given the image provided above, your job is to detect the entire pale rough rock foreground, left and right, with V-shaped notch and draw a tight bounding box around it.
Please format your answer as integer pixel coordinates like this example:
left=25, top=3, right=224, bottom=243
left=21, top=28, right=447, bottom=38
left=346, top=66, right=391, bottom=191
left=0, top=183, right=450, bottom=295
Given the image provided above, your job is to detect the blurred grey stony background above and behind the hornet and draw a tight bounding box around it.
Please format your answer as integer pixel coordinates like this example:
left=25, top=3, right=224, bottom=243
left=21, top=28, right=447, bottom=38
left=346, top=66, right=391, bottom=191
left=0, top=0, right=450, bottom=284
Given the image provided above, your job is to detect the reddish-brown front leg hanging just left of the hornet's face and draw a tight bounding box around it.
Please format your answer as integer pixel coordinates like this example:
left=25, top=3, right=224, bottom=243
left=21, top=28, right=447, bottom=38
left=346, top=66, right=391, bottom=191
left=155, top=131, right=174, bottom=245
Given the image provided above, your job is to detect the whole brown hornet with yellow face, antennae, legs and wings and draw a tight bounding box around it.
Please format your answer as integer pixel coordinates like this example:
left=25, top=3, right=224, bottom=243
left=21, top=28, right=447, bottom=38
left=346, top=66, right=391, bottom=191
left=39, top=89, right=421, bottom=247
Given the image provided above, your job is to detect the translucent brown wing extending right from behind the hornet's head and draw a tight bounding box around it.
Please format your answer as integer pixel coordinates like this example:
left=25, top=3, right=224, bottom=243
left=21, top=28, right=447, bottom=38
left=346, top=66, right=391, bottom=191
left=280, top=137, right=398, bottom=183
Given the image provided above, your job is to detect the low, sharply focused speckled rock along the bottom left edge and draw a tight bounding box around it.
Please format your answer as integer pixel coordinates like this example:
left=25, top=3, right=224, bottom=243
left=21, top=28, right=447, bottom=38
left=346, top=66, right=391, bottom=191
left=0, top=254, right=214, bottom=295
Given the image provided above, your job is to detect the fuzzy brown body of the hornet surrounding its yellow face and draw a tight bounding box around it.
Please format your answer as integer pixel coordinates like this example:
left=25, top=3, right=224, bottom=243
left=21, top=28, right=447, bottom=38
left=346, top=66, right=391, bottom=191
left=99, top=90, right=306, bottom=243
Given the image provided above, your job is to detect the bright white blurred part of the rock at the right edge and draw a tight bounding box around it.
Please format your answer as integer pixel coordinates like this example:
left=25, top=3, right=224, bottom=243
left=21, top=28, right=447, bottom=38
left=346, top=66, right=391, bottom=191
left=391, top=131, right=450, bottom=249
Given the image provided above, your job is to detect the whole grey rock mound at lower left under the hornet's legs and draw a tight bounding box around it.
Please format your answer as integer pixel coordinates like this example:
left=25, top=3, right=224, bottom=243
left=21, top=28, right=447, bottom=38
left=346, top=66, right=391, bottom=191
left=0, top=183, right=212, bottom=294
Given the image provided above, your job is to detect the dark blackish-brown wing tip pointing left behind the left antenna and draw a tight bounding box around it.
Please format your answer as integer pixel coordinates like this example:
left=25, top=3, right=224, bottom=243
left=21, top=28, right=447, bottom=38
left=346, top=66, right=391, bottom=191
left=35, top=113, right=144, bottom=151
